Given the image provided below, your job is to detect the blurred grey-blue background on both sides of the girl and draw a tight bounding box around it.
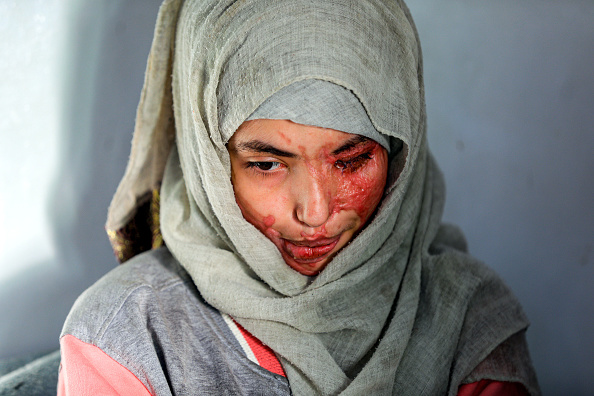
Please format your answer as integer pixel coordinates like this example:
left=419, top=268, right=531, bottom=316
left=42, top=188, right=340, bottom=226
left=0, top=0, right=594, bottom=395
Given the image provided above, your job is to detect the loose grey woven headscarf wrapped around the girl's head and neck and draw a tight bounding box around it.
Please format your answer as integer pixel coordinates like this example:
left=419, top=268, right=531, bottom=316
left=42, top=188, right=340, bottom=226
left=107, top=0, right=534, bottom=395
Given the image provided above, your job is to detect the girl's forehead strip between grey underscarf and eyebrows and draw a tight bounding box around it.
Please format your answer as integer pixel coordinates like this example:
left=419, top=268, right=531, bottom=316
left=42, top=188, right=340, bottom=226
left=229, top=119, right=371, bottom=156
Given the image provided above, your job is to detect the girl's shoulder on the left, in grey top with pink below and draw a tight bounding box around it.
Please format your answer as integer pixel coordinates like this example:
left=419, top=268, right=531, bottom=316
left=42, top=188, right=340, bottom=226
left=60, top=248, right=199, bottom=393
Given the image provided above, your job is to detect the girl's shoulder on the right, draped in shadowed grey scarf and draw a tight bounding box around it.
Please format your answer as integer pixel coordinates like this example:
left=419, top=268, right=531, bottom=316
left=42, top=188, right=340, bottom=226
left=420, top=249, right=537, bottom=393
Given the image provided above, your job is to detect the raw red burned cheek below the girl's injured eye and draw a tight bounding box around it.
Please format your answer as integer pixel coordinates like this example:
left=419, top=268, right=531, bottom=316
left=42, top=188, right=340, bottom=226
left=335, top=147, right=388, bottom=227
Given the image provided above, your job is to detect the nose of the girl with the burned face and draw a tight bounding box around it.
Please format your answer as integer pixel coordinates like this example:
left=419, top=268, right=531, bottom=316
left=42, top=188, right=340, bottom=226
left=295, top=174, right=332, bottom=228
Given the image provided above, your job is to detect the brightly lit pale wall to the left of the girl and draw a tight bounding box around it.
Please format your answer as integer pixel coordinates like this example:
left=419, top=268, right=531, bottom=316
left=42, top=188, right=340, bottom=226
left=0, top=0, right=160, bottom=358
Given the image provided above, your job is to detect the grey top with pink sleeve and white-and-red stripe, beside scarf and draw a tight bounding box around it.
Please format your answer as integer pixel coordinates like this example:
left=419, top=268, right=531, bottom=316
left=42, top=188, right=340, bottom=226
left=59, top=248, right=290, bottom=396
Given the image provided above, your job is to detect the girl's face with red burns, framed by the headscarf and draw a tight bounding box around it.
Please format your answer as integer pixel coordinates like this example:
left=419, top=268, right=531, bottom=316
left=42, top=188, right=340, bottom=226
left=228, top=120, right=388, bottom=275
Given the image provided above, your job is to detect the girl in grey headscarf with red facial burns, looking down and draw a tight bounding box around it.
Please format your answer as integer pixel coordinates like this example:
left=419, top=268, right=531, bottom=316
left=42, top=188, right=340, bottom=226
left=59, top=0, right=539, bottom=395
